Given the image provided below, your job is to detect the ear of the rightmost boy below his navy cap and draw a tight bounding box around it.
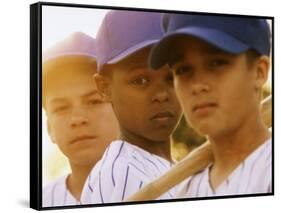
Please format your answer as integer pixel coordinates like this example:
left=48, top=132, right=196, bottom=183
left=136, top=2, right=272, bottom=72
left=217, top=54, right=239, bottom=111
left=255, top=56, right=270, bottom=89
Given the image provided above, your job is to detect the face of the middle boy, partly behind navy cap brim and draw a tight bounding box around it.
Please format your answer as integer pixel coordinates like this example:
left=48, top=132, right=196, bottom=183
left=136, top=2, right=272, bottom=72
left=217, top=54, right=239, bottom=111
left=99, top=48, right=181, bottom=141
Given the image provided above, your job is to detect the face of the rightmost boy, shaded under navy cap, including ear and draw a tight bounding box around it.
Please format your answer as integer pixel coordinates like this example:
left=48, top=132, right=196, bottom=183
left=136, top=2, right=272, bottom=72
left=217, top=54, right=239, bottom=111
left=172, top=37, right=268, bottom=137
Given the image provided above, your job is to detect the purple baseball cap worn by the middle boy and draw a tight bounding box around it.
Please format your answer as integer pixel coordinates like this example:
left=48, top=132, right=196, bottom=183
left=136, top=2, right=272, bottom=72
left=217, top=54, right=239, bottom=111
left=96, top=10, right=164, bottom=71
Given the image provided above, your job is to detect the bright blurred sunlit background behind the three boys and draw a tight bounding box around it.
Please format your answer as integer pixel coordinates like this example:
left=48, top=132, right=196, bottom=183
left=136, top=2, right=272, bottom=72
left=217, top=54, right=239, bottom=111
left=42, top=6, right=271, bottom=186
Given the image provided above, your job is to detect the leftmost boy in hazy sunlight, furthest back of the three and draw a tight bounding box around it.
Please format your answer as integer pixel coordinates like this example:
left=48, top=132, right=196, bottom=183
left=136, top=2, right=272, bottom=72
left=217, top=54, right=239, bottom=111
left=42, top=32, right=119, bottom=207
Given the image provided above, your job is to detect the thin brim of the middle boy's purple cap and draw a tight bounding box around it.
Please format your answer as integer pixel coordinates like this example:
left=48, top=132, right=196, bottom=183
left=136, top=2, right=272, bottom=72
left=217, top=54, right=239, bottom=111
left=106, top=39, right=159, bottom=64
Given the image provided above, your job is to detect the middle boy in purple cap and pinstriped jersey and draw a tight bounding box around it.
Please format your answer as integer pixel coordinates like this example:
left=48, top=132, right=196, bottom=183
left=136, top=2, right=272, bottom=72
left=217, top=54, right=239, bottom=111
left=81, top=11, right=181, bottom=204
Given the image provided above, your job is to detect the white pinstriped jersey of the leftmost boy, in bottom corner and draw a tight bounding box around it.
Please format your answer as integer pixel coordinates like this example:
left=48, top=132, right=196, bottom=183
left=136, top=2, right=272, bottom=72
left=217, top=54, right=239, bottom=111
left=42, top=175, right=80, bottom=207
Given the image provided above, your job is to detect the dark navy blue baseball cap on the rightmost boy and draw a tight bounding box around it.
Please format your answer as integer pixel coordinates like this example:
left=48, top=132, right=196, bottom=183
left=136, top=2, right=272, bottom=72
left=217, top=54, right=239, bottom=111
left=149, top=14, right=271, bottom=69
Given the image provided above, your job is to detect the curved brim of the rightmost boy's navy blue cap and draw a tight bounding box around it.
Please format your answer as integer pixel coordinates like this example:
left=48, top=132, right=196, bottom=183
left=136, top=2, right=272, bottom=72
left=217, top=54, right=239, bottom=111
left=149, top=27, right=249, bottom=70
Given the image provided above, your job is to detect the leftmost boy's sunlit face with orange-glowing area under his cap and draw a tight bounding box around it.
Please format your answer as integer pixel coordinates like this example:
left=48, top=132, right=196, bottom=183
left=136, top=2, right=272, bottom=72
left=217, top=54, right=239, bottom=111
left=43, top=57, right=118, bottom=165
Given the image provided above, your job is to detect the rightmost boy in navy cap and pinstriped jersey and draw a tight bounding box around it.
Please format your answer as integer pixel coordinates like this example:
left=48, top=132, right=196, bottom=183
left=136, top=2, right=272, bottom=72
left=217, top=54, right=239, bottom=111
left=150, top=14, right=272, bottom=197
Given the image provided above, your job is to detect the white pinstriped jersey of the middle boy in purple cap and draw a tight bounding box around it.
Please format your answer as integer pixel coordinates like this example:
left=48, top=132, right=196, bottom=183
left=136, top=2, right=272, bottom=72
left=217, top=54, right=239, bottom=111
left=81, top=140, right=176, bottom=204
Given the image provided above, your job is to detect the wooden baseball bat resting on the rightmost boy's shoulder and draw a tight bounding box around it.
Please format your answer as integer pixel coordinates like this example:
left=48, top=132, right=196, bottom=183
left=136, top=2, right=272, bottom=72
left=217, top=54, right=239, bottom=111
left=126, top=95, right=272, bottom=202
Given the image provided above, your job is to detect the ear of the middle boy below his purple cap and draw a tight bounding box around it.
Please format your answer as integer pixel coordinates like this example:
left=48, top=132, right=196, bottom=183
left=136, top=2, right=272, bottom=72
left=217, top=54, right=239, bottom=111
left=94, top=73, right=111, bottom=101
